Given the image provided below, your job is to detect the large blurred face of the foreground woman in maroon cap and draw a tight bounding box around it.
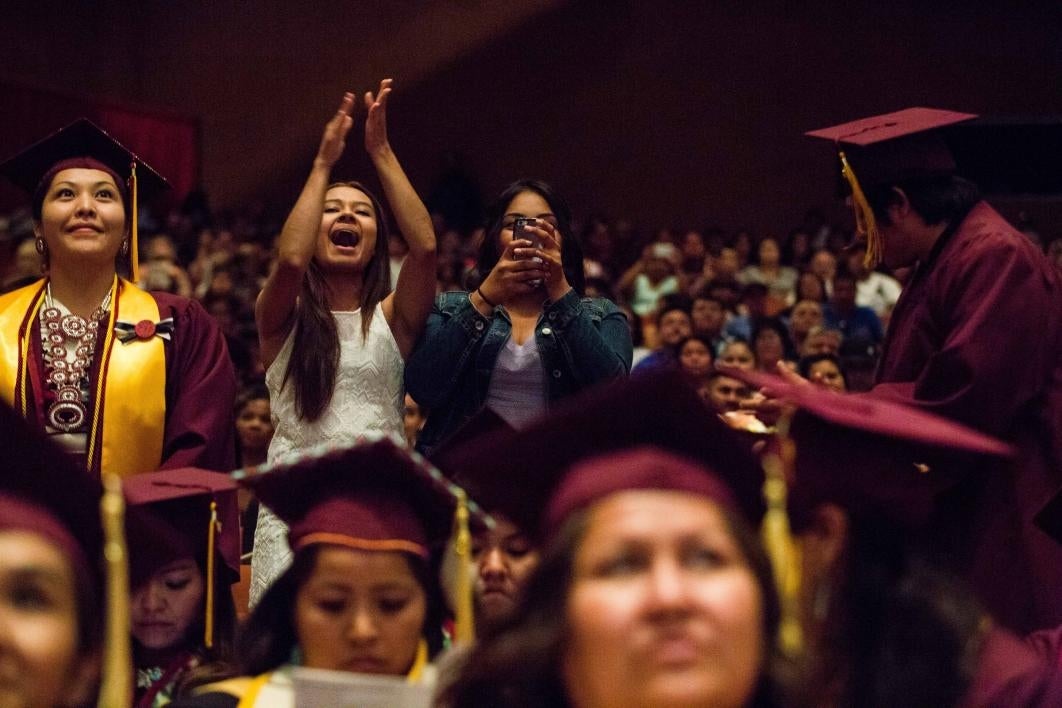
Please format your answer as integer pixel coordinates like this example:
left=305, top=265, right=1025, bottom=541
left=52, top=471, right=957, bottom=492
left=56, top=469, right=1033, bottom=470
left=562, top=490, right=766, bottom=708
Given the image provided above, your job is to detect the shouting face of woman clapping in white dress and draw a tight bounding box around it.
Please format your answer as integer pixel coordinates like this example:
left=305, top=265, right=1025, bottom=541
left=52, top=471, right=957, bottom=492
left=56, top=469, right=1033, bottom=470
left=313, top=185, right=377, bottom=272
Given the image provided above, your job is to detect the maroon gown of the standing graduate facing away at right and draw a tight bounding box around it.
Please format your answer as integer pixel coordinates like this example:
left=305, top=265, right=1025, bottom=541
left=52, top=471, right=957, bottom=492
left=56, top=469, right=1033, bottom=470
left=870, top=202, right=1062, bottom=634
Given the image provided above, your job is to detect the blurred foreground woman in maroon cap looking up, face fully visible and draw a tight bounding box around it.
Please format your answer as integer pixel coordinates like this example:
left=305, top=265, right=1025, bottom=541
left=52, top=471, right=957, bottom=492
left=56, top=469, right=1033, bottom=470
left=442, top=375, right=780, bottom=708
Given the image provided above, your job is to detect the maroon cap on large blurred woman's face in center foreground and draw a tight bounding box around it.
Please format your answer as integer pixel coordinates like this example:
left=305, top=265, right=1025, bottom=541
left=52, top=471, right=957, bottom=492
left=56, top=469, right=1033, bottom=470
left=437, top=372, right=764, bottom=542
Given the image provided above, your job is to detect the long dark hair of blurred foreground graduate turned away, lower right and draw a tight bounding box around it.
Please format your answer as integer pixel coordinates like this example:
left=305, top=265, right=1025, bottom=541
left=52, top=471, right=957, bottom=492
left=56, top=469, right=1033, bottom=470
left=806, top=515, right=983, bottom=708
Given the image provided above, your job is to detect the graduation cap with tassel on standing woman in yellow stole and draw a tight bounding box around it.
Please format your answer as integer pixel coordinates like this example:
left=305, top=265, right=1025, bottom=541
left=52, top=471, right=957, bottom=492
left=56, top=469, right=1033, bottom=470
left=0, top=118, right=169, bottom=280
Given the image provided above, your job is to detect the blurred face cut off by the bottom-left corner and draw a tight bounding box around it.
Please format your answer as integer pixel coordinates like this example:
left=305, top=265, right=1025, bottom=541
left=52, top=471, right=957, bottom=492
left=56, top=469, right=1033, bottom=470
left=0, top=531, right=99, bottom=707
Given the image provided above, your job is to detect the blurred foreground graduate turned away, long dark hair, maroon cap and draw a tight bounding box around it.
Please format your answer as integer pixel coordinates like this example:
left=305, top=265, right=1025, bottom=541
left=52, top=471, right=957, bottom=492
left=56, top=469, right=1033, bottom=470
left=726, top=374, right=1062, bottom=708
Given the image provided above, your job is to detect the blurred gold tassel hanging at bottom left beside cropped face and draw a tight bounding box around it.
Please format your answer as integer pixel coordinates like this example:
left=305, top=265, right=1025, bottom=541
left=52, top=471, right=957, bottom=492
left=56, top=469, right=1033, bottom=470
left=97, top=472, right=133, bottom=708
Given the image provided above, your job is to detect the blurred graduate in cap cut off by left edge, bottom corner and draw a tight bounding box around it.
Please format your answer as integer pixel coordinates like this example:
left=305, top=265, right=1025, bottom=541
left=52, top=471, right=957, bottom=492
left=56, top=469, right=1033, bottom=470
left=0, top=403, right=104, bottom=707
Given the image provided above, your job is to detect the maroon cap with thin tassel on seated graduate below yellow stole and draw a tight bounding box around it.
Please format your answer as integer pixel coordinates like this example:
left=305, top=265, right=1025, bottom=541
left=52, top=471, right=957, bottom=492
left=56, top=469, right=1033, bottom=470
left=122, top=467, right=240, bottom=647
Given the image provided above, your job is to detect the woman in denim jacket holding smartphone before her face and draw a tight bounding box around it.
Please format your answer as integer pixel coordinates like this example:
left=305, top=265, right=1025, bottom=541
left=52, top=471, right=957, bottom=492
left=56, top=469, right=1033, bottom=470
left=406, top=179, right=632, bottom=454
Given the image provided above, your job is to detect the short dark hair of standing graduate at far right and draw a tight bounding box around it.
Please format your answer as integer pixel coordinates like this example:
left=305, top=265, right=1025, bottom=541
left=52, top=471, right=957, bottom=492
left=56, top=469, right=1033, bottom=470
left=867, top=175, right=981, bottom=225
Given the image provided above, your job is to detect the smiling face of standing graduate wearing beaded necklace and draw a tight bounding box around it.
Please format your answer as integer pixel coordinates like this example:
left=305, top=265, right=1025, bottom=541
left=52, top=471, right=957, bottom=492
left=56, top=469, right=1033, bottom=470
left=37, top=168, right=125, bottom=269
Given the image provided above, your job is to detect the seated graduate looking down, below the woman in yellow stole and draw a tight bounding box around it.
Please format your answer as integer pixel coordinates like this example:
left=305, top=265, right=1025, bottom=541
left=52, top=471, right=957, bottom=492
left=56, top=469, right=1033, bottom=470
left=123, top=468, right=240, bottom=708
